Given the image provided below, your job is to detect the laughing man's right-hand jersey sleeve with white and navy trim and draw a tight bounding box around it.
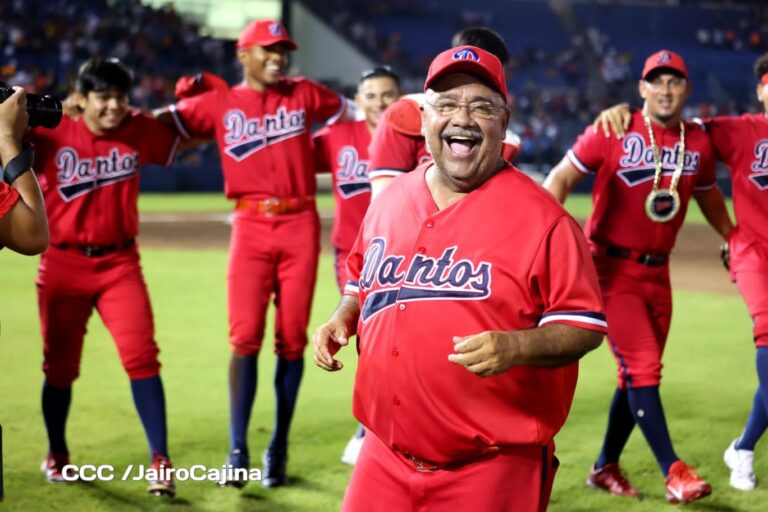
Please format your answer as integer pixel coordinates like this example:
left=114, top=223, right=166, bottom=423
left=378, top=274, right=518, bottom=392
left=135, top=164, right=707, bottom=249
left=529, top=216, right=608, bottom=332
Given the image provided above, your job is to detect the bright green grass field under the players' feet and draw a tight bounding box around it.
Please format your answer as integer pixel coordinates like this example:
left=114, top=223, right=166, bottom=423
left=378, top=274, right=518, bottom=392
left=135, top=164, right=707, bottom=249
left=0, top=194, right=756, bottom=512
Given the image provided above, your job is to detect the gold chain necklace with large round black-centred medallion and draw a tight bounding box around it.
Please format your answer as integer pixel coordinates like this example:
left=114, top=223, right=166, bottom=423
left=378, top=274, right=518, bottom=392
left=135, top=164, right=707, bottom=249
left=643, top=111, right=685, bottom=222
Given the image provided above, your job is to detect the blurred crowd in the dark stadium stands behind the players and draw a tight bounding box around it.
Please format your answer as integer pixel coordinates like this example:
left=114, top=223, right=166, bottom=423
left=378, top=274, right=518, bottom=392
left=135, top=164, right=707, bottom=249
left=0, top=0, right=768, bottom=170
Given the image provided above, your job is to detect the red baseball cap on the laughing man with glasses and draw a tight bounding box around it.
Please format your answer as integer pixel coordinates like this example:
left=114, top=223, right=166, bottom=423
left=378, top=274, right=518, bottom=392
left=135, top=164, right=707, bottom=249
left=424, top=46, right=508, bottom=103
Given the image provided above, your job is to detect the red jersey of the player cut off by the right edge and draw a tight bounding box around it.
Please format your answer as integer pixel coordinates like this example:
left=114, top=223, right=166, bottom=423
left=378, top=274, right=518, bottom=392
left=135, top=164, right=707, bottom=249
left=705, top=114, right=768, bottom=272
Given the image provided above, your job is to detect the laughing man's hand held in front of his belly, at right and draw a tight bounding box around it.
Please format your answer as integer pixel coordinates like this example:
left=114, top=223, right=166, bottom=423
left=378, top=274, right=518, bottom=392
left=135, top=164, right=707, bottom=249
left=448, top=331, right=519, bottom=377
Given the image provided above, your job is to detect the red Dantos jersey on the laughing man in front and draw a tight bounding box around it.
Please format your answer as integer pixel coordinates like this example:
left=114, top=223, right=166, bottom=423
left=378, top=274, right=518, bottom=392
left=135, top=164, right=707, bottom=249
left=345, top=163, right=606, bottom=463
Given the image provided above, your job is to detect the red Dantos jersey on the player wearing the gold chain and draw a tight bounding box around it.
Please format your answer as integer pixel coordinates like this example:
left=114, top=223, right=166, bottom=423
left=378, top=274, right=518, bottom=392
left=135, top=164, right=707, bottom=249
left=567, top=111, right=717, bottom=253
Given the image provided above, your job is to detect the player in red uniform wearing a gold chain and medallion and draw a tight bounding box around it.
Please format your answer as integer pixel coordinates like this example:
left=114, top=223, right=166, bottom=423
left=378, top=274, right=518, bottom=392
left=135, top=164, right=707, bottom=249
left=544, top=50, right=733, bottom=503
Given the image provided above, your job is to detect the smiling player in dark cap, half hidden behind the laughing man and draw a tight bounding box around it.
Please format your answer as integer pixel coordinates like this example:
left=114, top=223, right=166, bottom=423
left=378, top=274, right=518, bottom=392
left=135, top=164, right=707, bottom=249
left=313, top=66, right=400, bottom=465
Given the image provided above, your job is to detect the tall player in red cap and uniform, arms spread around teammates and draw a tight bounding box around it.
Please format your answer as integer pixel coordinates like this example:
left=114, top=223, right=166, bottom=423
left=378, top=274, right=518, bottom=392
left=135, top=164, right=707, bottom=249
left=159, top=20, right=354, bottom=488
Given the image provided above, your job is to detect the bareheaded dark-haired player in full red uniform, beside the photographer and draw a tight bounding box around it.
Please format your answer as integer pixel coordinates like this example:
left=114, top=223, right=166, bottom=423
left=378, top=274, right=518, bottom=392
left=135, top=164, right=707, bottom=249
left=30, top=58, right=178, bottom=496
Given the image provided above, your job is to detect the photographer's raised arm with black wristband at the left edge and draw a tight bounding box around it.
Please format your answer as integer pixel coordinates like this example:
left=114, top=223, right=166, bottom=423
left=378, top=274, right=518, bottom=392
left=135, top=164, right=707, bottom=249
left=0, top=87, right=49, bottom=255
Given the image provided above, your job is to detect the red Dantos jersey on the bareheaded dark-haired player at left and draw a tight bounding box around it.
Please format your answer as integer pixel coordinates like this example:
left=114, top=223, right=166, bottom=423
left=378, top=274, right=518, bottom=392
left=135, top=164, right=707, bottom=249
left=29, top=110, right=178, bottom=245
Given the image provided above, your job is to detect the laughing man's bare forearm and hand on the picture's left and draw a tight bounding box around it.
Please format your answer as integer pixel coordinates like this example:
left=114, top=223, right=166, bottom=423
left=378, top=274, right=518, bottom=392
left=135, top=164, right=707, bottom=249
left=312, top=295, right=360, bottom=372
